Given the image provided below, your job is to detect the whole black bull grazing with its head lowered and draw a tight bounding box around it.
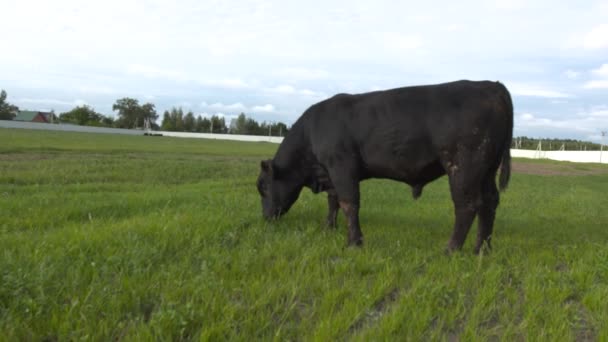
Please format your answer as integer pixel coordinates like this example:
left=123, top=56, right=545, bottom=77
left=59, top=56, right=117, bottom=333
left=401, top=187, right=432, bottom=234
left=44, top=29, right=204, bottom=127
left=257, top=81, right=513, bottom=252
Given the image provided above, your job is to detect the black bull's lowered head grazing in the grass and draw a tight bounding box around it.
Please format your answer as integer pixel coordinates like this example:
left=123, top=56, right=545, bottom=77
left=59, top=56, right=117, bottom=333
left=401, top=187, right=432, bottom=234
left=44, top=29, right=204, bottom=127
left=257, top=160, right=302, bottom=220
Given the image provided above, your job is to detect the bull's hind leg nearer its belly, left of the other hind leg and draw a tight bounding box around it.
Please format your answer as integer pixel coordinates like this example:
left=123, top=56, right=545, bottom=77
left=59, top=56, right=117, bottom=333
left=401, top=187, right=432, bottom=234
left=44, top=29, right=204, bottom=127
left=447, top=162, right=481, bottom=252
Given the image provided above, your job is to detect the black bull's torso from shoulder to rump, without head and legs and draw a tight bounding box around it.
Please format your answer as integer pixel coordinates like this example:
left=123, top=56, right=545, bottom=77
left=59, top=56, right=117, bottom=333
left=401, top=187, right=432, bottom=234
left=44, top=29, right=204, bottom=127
left=311, top=81, right=512, bottom=183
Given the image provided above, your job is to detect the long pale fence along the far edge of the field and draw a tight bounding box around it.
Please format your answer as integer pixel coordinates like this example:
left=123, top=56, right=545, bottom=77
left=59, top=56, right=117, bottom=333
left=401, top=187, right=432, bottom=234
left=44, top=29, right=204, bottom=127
left=0, top=120, right=608, bottom=164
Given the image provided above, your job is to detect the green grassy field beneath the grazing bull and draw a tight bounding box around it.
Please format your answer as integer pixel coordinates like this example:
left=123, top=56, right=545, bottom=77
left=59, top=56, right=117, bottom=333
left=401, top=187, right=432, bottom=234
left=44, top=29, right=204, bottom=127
left=0, top=129, right=608, bottom=341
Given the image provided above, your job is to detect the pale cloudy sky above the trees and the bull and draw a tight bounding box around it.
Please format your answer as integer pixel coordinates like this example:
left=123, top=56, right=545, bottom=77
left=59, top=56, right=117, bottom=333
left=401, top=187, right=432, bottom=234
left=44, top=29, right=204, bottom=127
left=0, top=0, right=608, bottom=141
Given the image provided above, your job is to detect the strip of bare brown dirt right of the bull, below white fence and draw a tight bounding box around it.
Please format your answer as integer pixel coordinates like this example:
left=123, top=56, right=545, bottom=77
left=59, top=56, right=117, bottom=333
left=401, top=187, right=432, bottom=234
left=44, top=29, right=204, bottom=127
left=511, top=161, right=608, bottom=176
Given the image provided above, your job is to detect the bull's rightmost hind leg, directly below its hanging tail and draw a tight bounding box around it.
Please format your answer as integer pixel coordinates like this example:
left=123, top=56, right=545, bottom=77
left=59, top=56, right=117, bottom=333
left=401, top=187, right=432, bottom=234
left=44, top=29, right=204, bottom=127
left=475, top=173, right=499, bottom=254
